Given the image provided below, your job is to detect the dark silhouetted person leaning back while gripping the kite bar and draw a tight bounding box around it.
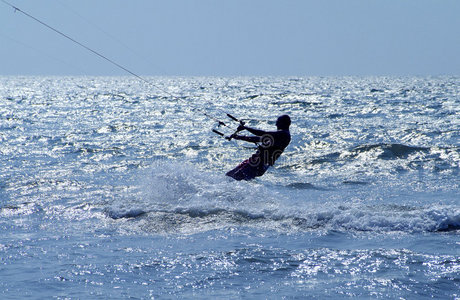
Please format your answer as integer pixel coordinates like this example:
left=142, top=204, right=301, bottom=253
left=226, top=115, right=291, bottom=180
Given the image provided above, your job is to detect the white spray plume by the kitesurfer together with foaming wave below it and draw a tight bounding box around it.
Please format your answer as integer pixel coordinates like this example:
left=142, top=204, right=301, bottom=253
left=106, top=163, right=460, bottom=234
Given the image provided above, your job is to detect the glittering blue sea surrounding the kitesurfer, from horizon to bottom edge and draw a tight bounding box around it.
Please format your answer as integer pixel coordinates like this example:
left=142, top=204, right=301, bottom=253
left=0, top=77, right=460, bottom=299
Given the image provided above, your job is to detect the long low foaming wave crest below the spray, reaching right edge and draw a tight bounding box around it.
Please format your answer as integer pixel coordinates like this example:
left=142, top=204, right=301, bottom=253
left=108, top=202, right=460, bottom=233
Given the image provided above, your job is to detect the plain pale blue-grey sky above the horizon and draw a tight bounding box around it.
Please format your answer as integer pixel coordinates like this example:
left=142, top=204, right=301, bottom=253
left=0, top=0, right=460, bottom=76
